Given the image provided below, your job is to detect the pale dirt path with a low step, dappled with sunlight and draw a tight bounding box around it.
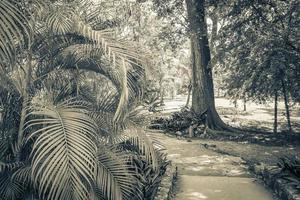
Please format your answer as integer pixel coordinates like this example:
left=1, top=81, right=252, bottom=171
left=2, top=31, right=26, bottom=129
left=151, top=132, right=273, bottom=200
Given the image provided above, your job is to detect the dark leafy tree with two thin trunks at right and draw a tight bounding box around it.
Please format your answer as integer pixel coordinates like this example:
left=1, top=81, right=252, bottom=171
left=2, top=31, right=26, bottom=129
left=219, top=1, right=299, bottom=132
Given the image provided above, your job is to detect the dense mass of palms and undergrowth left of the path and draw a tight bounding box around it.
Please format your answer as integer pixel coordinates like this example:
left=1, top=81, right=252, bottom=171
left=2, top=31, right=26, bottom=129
left=0, top=0, right=168, bottom=200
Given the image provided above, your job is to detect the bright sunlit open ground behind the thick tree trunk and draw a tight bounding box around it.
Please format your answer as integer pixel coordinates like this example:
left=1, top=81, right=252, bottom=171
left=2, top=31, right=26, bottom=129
left=162, top=96, right=300, bottom=132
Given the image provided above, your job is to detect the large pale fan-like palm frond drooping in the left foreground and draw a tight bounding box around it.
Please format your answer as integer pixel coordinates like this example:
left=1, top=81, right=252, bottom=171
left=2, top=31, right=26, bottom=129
left=28, top=101, right=97, bottom=200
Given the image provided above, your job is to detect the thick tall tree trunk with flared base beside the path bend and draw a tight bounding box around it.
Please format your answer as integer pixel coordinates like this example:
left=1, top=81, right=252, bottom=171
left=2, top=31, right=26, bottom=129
left=186, top=0, right=229, bottom=130
